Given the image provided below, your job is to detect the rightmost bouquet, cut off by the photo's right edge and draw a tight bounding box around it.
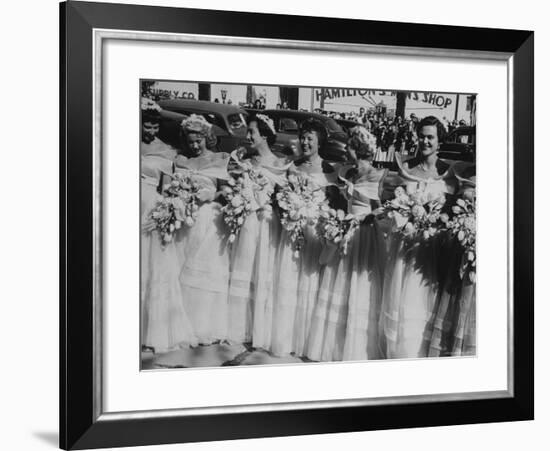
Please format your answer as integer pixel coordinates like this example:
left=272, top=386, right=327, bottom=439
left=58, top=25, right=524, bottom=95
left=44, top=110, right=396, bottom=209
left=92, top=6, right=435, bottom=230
left=442, top=199, right=476, bottom=282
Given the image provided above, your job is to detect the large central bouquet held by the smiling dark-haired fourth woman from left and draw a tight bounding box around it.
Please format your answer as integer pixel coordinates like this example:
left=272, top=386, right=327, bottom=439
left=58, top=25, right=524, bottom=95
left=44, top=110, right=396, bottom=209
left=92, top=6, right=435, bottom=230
left=276, top=174, right=326, bottom=257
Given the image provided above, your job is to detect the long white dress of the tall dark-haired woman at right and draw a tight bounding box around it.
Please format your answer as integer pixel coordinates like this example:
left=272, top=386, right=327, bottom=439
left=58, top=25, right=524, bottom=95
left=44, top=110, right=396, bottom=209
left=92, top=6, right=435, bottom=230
left=380, top=157, right=455, bottom=358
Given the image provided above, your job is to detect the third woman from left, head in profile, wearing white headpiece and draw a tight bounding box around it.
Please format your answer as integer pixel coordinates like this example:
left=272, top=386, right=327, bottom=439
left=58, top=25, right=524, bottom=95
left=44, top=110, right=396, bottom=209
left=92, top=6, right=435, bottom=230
left=229, top=114, right=290, bottom=349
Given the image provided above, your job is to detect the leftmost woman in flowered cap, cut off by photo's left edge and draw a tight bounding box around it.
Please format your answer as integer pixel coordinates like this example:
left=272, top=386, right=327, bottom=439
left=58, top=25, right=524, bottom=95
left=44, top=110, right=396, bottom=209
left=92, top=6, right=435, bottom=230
left=140, top=99, right=197, bottom=353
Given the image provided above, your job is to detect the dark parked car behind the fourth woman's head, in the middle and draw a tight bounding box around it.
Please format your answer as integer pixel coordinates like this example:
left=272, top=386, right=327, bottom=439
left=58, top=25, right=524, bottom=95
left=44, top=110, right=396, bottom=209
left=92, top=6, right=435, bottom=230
left=253, top=110, right=348, bottom=161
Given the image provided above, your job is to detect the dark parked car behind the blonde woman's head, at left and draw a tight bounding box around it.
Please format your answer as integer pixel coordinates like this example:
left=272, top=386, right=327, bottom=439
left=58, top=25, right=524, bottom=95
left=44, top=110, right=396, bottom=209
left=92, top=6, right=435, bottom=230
left=158, top=99, right=247, bottom=153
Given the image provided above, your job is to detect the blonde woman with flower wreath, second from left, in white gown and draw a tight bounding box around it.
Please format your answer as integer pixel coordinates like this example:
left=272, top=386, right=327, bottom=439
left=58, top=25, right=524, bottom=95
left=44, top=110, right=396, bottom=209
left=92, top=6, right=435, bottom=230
left=175, top=114, right=229, bottom=344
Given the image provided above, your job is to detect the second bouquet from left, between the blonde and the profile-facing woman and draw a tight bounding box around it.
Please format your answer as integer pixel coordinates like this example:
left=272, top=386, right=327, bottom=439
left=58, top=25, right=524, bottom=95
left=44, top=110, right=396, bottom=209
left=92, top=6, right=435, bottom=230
left=221, top=172, right=254, bottom=244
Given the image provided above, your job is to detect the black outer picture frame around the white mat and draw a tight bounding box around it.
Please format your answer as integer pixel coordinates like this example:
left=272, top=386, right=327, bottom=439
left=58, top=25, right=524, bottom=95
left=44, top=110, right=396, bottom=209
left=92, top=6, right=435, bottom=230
left=60, top=1, right=534, bottom=449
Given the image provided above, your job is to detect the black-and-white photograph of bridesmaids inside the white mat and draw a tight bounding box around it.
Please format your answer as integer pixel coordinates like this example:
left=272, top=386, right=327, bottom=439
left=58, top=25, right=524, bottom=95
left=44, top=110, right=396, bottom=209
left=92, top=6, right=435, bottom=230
left=141, top=79, right=477, bottom=370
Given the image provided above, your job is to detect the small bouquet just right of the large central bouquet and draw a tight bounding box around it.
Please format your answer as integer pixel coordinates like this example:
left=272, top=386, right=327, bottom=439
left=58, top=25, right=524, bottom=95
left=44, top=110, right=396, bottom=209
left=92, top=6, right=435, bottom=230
left=317, top=205, right=359, bottom=255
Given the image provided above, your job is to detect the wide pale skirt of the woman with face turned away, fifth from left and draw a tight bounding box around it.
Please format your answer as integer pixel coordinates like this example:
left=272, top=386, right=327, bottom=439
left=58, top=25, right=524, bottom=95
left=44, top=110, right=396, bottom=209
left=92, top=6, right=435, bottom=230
left=306, top=223, right=386, bottom=361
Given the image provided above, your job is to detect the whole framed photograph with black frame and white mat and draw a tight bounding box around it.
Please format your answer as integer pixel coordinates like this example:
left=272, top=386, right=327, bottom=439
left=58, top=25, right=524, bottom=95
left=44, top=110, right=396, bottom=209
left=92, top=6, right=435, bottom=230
left=60, top=2, right=534, bottom=449
